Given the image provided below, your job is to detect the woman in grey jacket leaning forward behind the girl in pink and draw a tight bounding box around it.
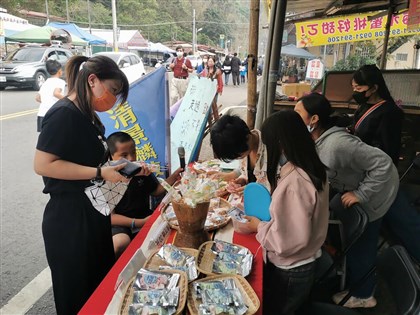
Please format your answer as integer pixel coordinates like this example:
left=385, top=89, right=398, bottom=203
left=295, top=93, right=399, bottom=308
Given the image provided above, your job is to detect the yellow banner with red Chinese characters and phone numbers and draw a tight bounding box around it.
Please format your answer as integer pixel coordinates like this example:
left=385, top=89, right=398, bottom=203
left=295, top=12, right=420, bottom=47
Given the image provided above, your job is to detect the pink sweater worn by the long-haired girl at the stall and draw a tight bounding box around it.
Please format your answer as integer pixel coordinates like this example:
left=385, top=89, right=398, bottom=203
left=257, top=162, right=329, bottom=266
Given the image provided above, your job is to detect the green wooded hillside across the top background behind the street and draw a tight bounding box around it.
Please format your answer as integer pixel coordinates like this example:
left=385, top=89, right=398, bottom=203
left=2, top=0, right=249, bottom=50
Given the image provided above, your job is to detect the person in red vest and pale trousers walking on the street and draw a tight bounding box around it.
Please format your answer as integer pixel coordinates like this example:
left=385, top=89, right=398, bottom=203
left=169, top=46, right=194, bottom=105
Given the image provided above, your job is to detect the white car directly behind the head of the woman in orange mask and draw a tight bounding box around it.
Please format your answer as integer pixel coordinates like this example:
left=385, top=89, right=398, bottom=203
left=95, top=52, right=146, bottom=83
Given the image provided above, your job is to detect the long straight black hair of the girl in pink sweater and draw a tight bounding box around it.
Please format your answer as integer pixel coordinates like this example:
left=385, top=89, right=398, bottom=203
left=261, top=110, right=327, bottom=191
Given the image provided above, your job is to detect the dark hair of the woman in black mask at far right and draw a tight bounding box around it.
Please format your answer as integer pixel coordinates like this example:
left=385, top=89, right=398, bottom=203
left=353, top=65, right=394, bottom=101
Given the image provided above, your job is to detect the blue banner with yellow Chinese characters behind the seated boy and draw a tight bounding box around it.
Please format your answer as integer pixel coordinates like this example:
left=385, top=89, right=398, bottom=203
left=98, top=68, right=169, bottom=175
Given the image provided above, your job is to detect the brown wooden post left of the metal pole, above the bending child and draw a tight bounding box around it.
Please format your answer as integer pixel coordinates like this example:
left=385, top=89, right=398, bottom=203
left=247, top=0, right=260, bottom=129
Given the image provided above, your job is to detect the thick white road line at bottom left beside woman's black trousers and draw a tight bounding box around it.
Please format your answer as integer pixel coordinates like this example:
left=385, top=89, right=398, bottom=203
left=0, top=267, right=52, bottom=315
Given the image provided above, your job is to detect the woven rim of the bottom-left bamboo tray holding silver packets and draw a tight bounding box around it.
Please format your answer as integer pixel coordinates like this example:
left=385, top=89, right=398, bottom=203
left=118, top=270, right=188, bottom=315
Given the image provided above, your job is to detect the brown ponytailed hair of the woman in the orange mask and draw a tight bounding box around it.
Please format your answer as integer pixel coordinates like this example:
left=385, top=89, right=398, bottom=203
left=66, top=55, right=129, bottom=125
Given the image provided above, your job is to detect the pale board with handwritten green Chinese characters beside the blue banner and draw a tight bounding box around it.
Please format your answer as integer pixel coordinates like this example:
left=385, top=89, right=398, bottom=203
left=171, top=76, right=217, bottom=171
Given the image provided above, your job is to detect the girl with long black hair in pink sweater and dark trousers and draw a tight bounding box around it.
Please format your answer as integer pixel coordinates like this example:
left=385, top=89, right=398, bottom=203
left=241, top=110, right=329, bottom=314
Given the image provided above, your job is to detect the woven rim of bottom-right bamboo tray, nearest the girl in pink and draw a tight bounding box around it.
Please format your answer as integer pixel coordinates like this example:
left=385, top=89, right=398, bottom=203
left=187, top=275, right=260, bottom=315
